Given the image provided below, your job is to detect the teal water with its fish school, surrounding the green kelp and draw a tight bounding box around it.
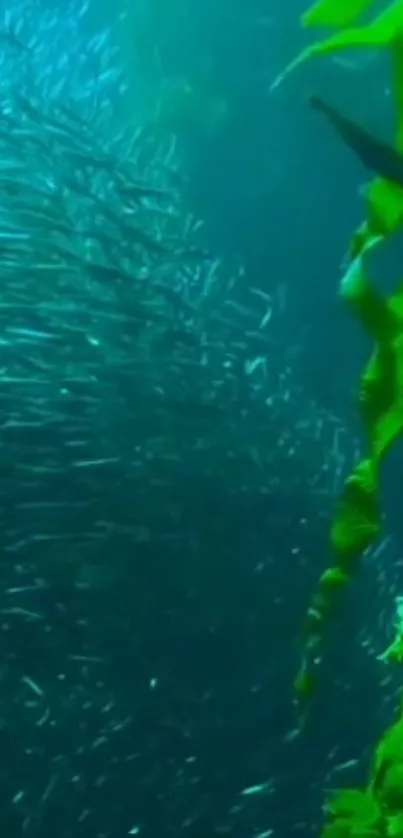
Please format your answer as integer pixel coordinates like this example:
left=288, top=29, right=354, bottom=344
left=0, top=0, right=401, bottom=838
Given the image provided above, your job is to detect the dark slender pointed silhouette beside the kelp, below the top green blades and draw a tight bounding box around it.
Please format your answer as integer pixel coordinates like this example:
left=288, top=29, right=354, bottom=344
left=309, top=95, right=403, bottom=188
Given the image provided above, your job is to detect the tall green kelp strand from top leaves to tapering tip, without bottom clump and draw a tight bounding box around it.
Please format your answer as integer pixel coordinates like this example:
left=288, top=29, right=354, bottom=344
left=273, top=0, right=403, bottom=716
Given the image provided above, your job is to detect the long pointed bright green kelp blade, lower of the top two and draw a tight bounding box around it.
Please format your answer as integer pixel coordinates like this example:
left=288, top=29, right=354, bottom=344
left=270, top=0, right=403, bottom=92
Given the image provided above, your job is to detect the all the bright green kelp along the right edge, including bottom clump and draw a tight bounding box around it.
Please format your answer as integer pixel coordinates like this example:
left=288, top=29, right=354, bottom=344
left=280, top=0, right=403, bottom=838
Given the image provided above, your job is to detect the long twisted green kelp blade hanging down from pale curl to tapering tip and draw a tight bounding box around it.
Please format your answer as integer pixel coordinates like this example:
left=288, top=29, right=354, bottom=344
left=295, top=255, right=403, bottom=698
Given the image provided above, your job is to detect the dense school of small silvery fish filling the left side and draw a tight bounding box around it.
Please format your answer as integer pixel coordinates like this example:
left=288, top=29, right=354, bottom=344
left=0, top=13, right=368, bottom=838
